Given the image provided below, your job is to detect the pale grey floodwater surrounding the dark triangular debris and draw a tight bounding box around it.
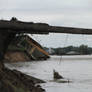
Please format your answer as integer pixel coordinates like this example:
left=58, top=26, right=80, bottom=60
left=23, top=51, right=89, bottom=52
left=6, top=55, right=92, bottom=92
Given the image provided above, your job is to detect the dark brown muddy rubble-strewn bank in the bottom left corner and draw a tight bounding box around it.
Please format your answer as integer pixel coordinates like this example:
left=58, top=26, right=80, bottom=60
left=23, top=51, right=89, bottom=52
left=0, top=68, right=45, bottom=92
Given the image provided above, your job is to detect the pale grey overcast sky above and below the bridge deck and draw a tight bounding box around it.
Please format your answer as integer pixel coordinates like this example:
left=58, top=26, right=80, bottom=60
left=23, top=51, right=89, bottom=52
left=0, top=0, right=92, bottom=47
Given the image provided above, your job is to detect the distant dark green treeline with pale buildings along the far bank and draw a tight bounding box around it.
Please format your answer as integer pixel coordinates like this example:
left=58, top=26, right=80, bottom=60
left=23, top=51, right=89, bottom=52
left=44, top=44, right=92, bottom=55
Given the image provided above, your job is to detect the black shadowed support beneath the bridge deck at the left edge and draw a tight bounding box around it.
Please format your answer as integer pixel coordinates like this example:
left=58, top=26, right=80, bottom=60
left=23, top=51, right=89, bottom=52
left=0, top=30, right=16, bottom=69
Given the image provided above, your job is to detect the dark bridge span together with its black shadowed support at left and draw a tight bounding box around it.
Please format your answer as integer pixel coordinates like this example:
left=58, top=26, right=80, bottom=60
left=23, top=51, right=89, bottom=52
left=0, top=20, right=92, bottom=64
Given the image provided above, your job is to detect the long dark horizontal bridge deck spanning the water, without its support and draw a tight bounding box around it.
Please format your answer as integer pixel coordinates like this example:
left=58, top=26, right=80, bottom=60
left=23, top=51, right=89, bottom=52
left=0, top=20, right=92, bottom=35
